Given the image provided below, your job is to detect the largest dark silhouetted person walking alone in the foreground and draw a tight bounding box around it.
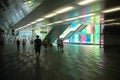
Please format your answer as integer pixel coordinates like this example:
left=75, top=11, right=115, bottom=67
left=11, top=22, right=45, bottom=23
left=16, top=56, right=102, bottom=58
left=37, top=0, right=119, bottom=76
left=34, top=35, right=42, bottom=56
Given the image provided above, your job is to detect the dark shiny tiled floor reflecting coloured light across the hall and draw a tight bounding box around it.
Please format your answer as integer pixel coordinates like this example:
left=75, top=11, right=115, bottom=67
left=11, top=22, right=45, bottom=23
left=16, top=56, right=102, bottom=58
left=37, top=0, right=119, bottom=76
left=0, top=42, right=120, bottom=80
